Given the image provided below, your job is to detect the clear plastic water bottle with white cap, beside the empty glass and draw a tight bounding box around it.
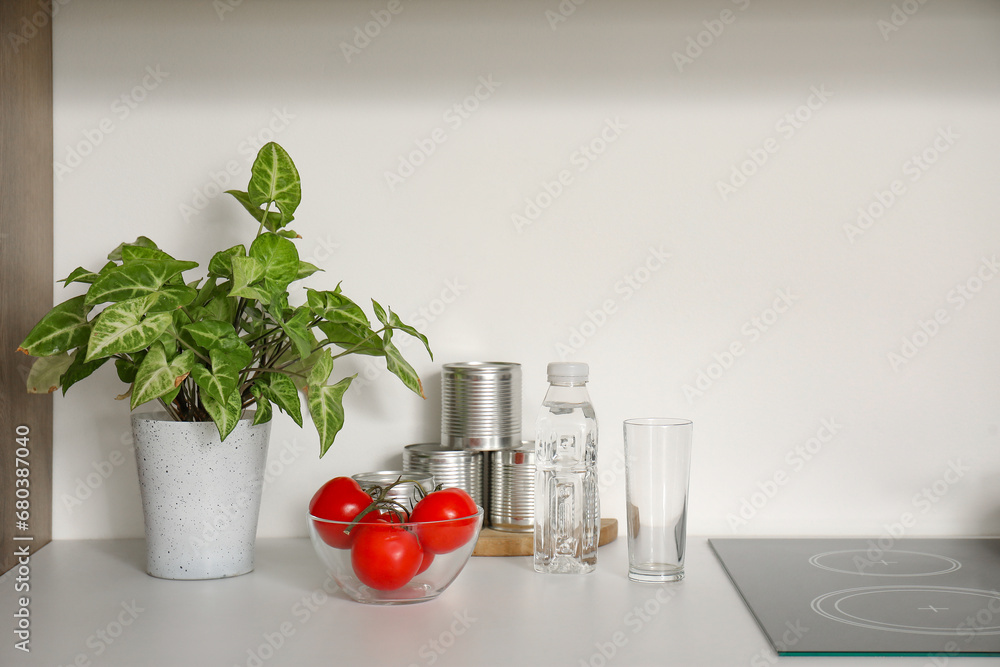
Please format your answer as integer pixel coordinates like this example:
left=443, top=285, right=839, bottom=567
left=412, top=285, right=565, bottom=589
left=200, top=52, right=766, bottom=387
left=535, top=362, right=601, bottom=574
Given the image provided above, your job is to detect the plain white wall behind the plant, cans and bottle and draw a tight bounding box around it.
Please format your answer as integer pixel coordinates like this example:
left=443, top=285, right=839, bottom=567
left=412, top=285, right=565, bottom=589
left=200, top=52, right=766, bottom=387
left=54, top=0, right=1000, bottom=538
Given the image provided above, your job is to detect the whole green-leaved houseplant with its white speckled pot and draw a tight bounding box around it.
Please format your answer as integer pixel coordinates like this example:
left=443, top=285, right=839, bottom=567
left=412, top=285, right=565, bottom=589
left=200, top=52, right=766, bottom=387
left=18, top=142, right=433, bottom=579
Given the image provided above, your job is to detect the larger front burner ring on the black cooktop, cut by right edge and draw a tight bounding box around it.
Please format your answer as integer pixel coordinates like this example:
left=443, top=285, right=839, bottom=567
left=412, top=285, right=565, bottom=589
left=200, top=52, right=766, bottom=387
left=811, top=586, right=1000, bottom=638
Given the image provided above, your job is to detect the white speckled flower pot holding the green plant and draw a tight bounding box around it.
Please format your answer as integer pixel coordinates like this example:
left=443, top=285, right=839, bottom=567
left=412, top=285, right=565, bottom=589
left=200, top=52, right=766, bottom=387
left=132, top=413, right=271, bottom=579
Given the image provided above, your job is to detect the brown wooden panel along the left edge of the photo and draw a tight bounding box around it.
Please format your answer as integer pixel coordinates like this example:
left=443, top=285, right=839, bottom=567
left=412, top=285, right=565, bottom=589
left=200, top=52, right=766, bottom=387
left=0, top=0, right=53, bottom=572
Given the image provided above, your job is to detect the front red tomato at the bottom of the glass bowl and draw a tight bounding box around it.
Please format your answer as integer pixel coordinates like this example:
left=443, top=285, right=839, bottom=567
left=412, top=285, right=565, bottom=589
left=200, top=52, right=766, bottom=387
left=351, top=522, right=424, bottom=591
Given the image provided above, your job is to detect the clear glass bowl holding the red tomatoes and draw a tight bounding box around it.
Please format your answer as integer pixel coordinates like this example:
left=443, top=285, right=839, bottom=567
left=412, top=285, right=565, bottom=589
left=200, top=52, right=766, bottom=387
left=309, top=507, right=484, bottom=604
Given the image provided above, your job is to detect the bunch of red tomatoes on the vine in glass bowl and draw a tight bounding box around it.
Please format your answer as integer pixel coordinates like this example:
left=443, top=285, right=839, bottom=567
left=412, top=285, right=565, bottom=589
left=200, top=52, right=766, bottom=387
left=309, top=477, right=479, bottom=591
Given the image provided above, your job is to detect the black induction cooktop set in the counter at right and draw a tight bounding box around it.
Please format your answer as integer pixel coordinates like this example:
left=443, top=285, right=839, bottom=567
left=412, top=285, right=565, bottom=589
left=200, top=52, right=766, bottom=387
left=709, top=537, right=1000, bottom=656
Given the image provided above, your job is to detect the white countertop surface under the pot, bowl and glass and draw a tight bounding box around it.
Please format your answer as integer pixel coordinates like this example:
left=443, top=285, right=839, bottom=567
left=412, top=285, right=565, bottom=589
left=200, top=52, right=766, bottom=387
left=0, top=537, right=936, bottom=667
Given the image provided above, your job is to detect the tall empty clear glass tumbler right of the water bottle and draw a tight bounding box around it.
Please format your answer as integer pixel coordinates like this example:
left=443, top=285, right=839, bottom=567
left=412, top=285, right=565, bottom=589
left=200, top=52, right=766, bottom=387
left=625, top=418, right=693, bottom=583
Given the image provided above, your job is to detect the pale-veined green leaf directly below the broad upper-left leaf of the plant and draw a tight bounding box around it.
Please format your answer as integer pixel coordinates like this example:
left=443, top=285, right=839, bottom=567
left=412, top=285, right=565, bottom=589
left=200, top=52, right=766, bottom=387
left=86, top=296, right=172, bottom=361
